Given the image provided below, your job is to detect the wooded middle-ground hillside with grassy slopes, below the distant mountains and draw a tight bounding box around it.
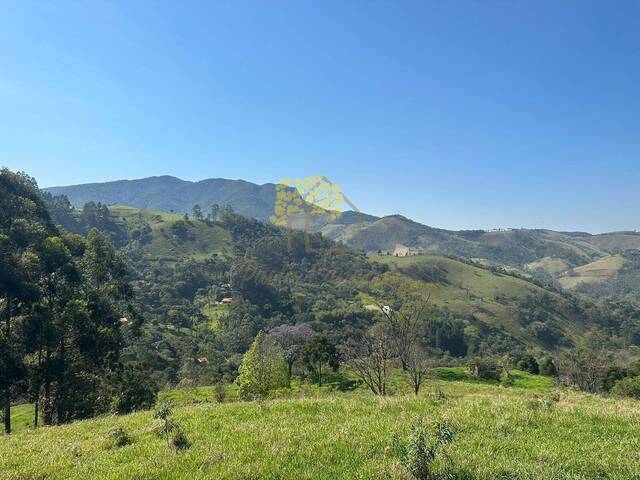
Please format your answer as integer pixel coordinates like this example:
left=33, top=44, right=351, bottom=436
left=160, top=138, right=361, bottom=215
left=41, top=172, right=634, bottom=382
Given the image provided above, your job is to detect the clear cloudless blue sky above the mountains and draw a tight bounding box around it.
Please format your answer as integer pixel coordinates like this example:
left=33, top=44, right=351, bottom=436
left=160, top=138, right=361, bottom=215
left=0, top=0, right=640, bottom=232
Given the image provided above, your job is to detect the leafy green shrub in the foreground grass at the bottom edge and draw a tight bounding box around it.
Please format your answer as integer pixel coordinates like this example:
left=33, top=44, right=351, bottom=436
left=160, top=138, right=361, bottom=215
left=393, top=422, right=453, bottom=480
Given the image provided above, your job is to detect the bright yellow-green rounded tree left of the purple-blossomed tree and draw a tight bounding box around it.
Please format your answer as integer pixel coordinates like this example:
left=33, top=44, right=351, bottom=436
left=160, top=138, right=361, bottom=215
left=237, top=332, right=289, bottom=400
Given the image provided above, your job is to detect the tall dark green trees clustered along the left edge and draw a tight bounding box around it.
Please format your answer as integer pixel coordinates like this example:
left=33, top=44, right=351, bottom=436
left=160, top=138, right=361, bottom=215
left=0, top=169, right=139, bottom=433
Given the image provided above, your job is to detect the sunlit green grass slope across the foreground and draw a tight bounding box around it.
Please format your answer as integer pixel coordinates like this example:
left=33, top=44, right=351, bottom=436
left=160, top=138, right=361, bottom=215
left=0, top=380, right=640, bottom=480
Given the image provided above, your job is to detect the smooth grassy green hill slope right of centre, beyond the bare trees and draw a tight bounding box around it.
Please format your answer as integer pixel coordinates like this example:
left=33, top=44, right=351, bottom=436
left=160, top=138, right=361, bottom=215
left=370, top=255, right=593, bottom=348
